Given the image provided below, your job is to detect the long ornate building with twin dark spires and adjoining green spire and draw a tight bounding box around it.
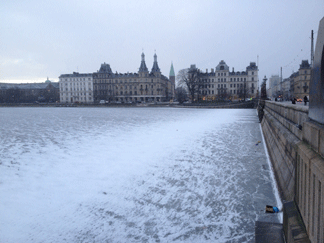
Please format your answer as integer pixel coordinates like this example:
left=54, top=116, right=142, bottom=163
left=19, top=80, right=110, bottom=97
left=93, top=53, right=175, bottom=102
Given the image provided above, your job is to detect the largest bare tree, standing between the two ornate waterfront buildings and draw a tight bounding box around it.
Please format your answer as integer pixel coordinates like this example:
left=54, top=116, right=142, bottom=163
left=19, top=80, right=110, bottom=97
left=177, top=66, right=201, bottom=101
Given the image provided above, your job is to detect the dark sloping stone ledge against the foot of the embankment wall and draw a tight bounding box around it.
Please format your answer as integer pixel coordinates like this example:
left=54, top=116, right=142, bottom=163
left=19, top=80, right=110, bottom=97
left=283, top=201, right=311, bottom=243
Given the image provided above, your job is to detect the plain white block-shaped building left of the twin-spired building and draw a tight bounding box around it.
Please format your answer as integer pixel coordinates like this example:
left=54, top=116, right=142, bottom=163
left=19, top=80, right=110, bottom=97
left=59, top=72, right=93, bottom=103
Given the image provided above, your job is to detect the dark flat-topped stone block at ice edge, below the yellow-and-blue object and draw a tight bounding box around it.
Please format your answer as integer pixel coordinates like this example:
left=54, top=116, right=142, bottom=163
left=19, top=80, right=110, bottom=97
left=255, top=221, right=285, bottom=243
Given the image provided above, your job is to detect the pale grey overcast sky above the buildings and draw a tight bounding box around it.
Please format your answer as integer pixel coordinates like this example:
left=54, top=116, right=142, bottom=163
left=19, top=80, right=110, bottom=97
left=0, top=0, right=324, bottom=83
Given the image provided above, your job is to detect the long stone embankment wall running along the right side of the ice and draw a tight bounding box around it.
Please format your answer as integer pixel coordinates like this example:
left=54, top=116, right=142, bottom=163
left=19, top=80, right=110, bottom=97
left=261, top=101, right=324, bottom=243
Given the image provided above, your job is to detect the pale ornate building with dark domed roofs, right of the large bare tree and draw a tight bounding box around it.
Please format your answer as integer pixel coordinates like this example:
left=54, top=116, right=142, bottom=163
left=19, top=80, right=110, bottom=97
left=191, top=60, right=259, bottom=100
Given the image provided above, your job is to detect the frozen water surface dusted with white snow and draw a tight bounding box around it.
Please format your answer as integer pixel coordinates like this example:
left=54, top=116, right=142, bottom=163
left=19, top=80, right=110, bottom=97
left=0, top=108, right=279, bottom=243
